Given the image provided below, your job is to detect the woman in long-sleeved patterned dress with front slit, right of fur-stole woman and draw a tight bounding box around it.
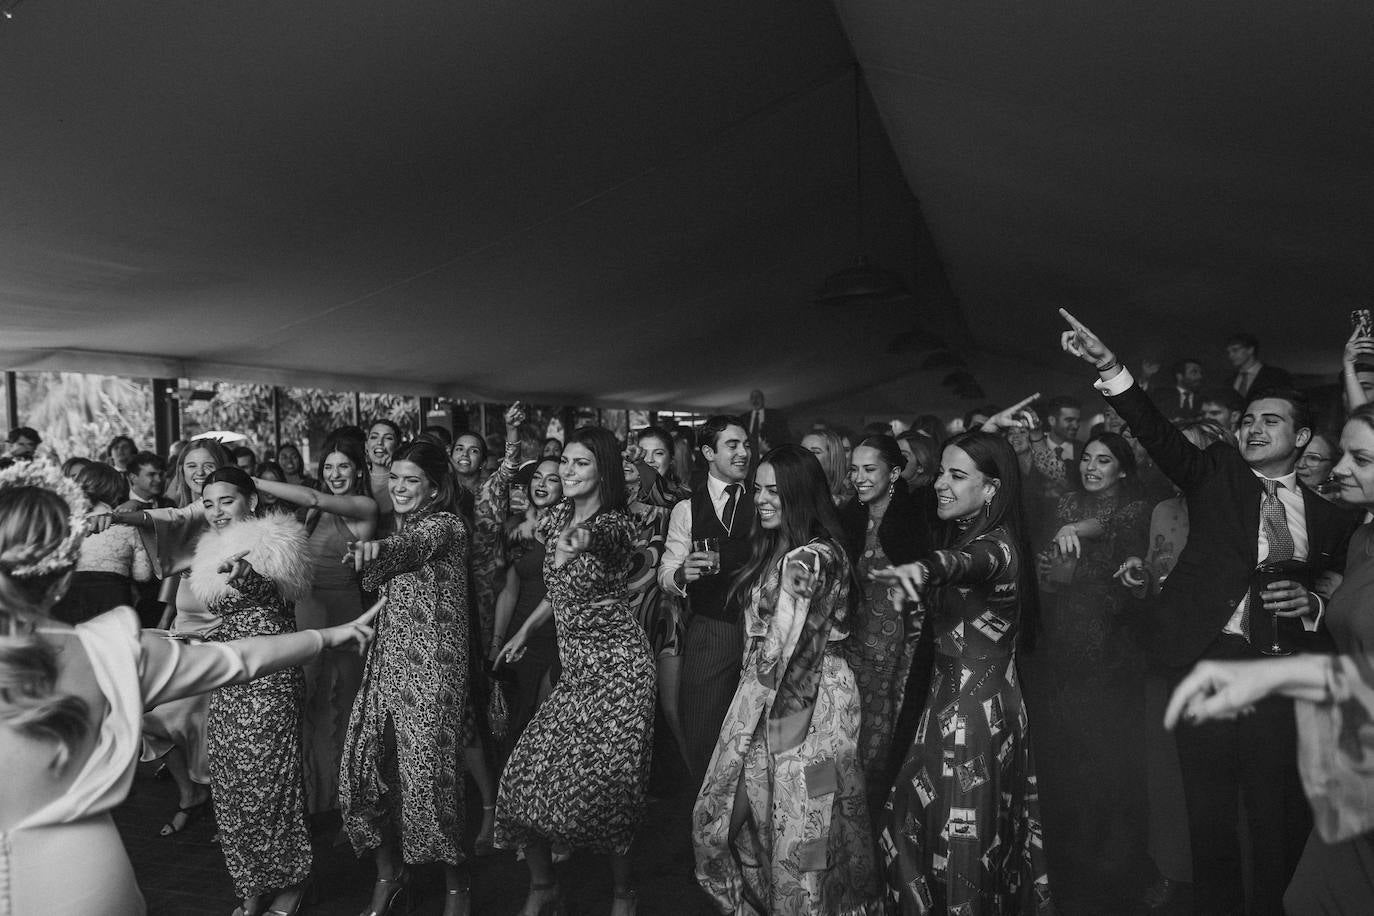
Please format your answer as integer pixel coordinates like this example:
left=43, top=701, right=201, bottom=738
left=339, top=439, right=474, bottom=916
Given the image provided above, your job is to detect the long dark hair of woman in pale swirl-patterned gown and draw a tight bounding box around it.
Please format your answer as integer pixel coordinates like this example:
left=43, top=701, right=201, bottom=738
left=725, top=445, right=852, bottom=607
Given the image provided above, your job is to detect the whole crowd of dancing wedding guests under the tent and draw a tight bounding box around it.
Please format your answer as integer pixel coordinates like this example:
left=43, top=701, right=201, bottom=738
left=0, top=313, right=1374, bottom=916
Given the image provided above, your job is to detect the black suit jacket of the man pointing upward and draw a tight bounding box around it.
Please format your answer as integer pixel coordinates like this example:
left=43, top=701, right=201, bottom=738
left=1107, top=386, right=1360, bottom=667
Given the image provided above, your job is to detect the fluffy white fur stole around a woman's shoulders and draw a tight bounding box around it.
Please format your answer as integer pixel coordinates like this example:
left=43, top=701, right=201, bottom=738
left=187, top=514, right=315, bottom=604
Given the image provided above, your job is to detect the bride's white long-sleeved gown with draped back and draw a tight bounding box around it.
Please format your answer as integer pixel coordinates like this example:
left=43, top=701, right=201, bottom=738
left=0, top=607, right=311, bottom=916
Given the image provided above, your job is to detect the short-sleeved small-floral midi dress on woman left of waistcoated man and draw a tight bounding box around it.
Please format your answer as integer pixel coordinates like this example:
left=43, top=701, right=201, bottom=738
left=496, top=500, right=657, bottom=854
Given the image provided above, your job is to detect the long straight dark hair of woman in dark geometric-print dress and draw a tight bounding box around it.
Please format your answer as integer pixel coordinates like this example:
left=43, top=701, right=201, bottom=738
left=945, top=433, right=1040, bottom=651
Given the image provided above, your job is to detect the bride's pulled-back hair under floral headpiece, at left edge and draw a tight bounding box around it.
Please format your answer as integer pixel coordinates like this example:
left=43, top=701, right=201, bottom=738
left=0, top=486, right=89, bottom=769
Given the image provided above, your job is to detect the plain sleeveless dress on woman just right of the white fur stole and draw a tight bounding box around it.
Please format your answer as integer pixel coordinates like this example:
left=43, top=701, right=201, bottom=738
left=295, top=512, right=363, bottom=812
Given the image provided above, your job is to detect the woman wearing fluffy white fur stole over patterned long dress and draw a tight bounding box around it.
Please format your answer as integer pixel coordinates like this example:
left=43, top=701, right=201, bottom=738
left=183, top=466, right=313, bottom=916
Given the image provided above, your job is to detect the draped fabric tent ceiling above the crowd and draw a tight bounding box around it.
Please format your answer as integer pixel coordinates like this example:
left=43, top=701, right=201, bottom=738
left=0, top=0, right=1374, bottom=420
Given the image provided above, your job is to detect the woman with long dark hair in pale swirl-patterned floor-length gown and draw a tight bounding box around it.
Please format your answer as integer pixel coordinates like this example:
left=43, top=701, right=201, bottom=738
left=692, top=445, right=882, bottom=916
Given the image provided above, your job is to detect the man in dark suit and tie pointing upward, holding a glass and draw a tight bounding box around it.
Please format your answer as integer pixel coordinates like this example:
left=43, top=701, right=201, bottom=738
left=1063, top=312, right=1359, bottom=916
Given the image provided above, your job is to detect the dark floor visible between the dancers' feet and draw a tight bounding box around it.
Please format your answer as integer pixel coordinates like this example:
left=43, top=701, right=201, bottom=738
left=115, top=768, right=713, bottom=916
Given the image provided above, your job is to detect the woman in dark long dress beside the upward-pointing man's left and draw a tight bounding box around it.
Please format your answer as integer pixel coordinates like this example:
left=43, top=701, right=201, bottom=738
left=1024, top=433, right=1150, bottom=913
